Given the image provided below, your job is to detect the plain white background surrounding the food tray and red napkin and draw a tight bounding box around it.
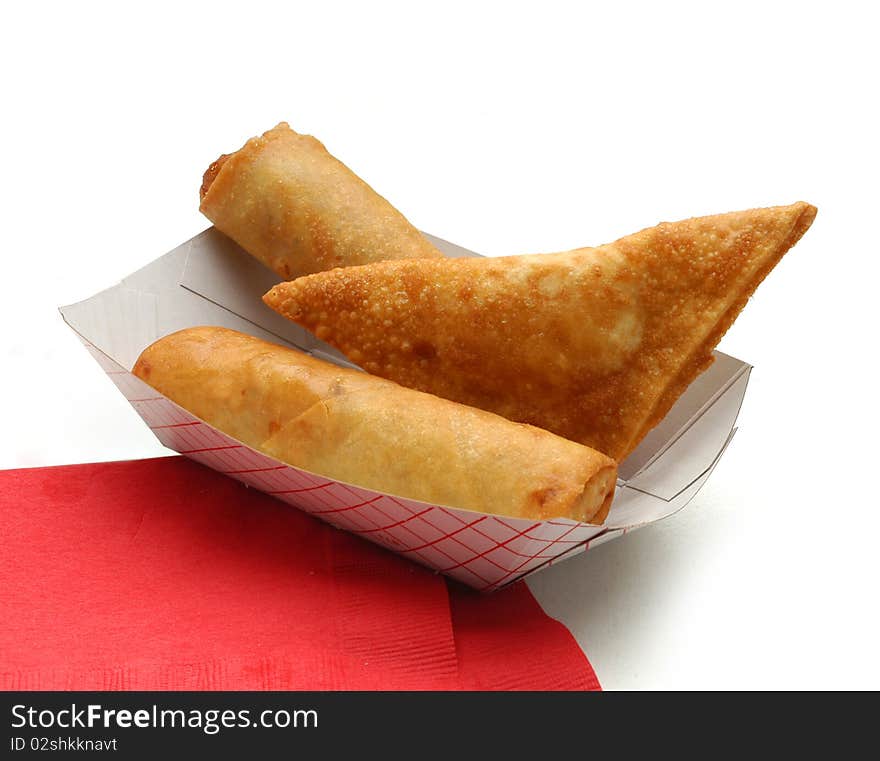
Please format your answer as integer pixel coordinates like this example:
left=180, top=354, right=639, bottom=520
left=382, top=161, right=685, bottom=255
left=0, top=1, right=880, bottom=689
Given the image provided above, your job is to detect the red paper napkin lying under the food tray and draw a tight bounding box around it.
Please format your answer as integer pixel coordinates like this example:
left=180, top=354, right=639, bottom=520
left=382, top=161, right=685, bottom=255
left=0, top=457, right=599, bottom=690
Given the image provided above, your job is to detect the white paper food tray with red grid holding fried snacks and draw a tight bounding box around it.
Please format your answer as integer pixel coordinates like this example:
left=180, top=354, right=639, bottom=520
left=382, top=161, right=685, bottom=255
left=60, top=228, right=751, bottom=591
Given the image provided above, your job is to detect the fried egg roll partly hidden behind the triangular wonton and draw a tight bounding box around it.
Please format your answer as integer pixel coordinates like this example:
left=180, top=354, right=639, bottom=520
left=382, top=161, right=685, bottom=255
left=200, top=122, right=442, bottom=280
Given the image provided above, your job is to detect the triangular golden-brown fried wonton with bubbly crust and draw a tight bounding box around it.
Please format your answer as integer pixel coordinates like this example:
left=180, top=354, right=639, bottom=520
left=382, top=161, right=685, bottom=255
left=264, top=202, right=816, bottom=460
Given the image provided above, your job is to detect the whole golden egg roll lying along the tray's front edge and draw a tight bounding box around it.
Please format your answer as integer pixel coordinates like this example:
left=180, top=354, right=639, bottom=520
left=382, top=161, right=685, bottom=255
left=133, top=327, right=617, bottom=523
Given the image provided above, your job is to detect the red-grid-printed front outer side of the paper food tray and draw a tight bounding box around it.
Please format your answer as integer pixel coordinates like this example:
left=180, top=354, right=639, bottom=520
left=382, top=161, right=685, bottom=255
left=87, top=344, right=614, bottom=591
